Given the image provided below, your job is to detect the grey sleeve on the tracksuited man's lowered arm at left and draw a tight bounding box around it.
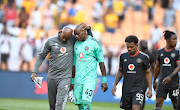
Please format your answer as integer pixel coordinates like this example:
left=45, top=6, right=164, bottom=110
left=33, top=40, right=51, bottom=73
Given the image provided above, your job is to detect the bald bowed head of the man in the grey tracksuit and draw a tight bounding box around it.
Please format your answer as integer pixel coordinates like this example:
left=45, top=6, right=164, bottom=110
left=59, top=26, right=73, bottom=43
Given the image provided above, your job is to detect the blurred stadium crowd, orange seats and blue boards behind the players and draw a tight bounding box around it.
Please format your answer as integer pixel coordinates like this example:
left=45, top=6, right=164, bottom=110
left=0, top=0, right=180, bottom=109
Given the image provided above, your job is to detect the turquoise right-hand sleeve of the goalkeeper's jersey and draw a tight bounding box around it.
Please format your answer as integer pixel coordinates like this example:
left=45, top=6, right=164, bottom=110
left=95, top=42, right=104, bottom=63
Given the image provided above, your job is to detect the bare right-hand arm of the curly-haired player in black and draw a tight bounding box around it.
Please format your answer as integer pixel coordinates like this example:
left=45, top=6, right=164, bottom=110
left=146, top=69, right=152, bottom=98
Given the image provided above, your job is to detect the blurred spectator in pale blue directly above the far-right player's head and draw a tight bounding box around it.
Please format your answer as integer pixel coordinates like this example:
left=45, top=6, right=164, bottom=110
left=164, top=4, right=175, bottom=29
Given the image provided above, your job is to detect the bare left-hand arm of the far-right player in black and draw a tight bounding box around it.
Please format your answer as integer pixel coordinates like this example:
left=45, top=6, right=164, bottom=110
left=153, top=61, right=160, bottom=90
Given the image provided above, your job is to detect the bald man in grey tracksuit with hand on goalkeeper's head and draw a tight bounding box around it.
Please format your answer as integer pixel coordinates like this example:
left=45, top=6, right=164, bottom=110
left=31, top=23, right=92, bottom=110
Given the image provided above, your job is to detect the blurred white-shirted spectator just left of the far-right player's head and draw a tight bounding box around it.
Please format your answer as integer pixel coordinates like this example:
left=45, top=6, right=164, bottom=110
left=151, top=25, right=163, bottom=45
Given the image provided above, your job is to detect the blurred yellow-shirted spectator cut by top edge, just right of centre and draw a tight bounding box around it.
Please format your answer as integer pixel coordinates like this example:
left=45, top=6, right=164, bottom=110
left=112, top=0, right=126, bottom=28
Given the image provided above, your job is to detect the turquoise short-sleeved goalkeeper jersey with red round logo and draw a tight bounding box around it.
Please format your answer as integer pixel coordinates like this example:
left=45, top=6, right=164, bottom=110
left=74, top=36, right=104, bottom=84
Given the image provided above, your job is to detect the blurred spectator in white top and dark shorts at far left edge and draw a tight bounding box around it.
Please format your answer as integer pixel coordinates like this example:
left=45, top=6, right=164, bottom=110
left=0, top=26, right=11, bottom=70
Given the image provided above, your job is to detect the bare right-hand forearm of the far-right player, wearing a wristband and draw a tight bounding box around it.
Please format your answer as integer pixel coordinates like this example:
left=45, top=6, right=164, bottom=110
left=162, top=61, right=180, bottom=84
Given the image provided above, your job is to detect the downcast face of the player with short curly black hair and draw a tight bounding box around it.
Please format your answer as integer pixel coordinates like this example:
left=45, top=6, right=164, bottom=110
left=126, top=42, right=138, bottom=55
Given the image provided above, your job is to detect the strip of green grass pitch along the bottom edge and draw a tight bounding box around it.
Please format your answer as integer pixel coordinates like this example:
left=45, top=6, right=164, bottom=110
left=0, top=98, right=173, bottom=110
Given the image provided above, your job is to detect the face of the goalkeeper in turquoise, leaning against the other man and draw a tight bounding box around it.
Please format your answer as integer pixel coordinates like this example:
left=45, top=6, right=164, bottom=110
left=74, top=26, right=86, bottom=41
